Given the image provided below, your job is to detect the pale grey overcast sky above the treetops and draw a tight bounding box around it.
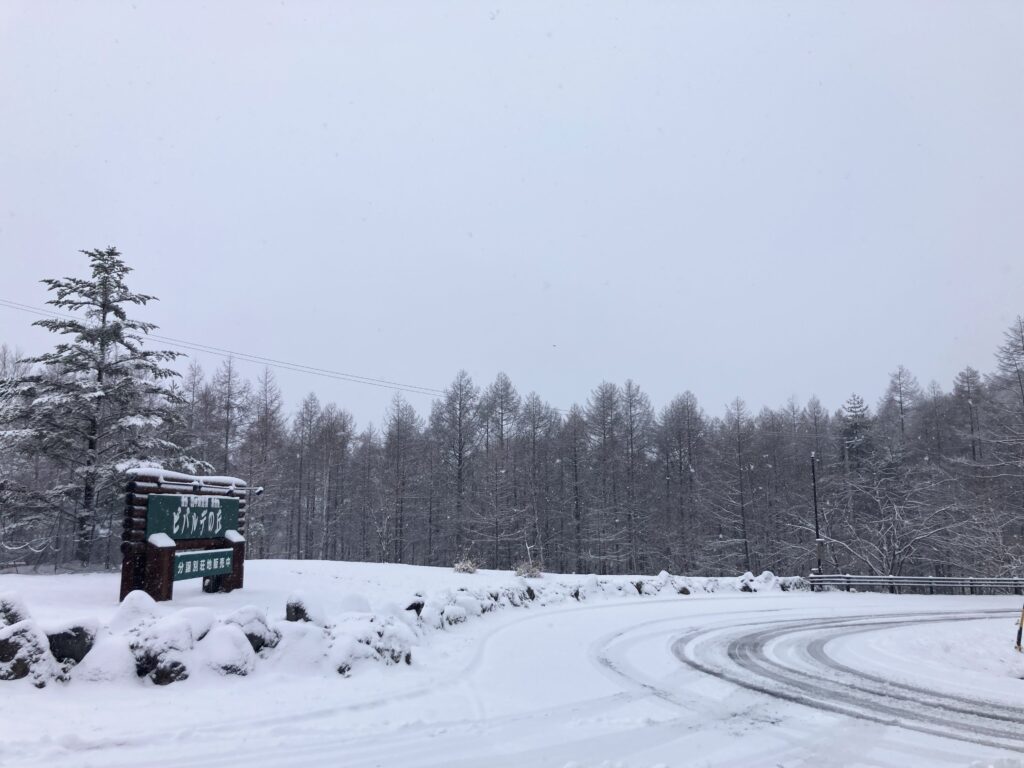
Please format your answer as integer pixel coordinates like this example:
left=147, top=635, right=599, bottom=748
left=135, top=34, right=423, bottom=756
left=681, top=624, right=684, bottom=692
left=0, top=0, right=1024, bottom=424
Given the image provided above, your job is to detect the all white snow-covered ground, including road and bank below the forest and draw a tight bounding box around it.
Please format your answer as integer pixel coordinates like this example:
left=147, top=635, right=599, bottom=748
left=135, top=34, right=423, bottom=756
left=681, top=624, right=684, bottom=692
left=0, top=561, right=1024, bottom=768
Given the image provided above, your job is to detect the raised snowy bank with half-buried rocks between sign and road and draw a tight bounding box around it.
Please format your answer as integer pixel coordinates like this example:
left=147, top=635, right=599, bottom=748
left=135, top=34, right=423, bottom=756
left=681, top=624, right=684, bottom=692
left=0, top=561, right=804, bottom=686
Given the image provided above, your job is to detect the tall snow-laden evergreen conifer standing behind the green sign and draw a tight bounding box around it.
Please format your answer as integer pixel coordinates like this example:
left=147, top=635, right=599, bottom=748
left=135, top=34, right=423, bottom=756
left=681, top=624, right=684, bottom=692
left=3, top=248, right=180, bottom=564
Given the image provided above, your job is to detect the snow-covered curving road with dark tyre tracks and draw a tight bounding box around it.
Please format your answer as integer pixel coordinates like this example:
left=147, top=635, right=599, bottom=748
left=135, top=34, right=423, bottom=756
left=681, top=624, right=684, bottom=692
left=0, top=593, right=1024, bottom=768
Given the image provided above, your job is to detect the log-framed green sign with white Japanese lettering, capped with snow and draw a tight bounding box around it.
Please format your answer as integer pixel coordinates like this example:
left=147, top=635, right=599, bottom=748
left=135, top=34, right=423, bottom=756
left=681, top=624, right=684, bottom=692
left=121, top=469, right=263, bottom=600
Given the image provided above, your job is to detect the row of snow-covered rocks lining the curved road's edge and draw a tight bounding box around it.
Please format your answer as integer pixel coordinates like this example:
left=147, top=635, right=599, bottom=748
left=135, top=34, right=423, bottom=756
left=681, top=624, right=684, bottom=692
left=0, top=561, right=805, bottom=686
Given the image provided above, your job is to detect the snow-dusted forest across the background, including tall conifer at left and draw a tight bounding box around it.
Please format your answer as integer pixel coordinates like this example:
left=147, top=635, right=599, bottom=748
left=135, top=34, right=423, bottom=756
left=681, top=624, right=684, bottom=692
left=0, top=249, right=1024, bottom=575
